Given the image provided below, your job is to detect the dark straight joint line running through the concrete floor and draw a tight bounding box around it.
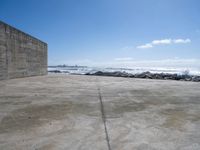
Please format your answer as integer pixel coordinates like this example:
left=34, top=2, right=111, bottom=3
left=98, top=86, right=111, bottom=150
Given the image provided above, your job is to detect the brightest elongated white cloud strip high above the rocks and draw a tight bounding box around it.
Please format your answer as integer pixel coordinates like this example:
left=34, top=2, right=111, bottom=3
left=137, top=38, right=191, bottom=49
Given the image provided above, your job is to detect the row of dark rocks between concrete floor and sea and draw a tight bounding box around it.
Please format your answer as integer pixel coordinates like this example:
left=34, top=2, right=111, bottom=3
left=85, top=71, right=200, bottom=82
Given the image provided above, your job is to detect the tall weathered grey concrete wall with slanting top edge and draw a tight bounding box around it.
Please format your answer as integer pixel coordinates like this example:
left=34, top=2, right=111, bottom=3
left=0, top=21, right=47, bottom=80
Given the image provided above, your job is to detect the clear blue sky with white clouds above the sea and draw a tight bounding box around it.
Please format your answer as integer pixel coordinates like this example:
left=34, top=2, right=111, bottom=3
left=0, top=0, right=200, bottom=67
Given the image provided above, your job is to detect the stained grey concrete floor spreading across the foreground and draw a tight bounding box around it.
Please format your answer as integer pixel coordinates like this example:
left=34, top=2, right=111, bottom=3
left=0, top=75, right=200, bottom=150
